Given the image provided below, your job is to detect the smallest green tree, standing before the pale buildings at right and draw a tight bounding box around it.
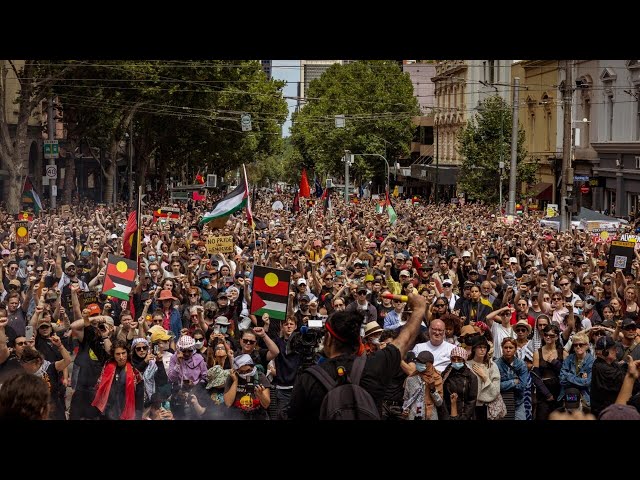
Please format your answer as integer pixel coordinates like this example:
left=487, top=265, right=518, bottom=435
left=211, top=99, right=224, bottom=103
left=458, top=95, right=536, bottom=204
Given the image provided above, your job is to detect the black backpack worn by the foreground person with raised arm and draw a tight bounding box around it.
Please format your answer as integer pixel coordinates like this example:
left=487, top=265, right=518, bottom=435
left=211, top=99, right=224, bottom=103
left=309, top=355, right=380, bottom=420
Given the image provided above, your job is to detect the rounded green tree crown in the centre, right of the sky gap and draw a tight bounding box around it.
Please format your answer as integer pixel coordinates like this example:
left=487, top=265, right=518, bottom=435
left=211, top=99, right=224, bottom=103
left=291, top=60, right=420, bottom=181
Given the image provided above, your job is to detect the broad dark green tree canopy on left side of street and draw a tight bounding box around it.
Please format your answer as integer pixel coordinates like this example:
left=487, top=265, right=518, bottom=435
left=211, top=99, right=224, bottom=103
left=55, top=60, right=287, bottom=175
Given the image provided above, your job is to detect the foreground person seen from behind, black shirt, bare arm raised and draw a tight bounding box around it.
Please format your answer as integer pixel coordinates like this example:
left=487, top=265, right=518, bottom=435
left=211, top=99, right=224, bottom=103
left=289, top=293, right=426, bottom=420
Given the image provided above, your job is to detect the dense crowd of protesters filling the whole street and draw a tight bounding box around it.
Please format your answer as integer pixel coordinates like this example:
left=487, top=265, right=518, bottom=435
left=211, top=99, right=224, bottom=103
left=0, top=190, right=640, bottom=420
